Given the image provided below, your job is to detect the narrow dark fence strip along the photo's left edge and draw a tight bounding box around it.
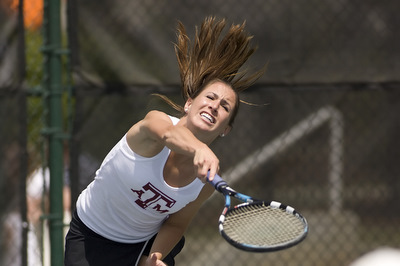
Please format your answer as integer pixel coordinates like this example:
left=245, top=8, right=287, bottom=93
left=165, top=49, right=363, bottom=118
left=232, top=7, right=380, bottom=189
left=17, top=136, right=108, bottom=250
left=0, top=1, right=27, bottom=265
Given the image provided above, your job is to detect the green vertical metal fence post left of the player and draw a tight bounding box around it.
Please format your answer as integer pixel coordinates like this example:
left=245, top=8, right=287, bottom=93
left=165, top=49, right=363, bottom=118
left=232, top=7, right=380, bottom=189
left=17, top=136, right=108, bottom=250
left=42, top=0, right=64, bottom=266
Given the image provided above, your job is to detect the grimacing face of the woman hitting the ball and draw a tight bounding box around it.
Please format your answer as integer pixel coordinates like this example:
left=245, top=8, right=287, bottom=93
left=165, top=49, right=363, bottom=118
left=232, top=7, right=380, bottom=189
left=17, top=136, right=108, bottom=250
left=185, top=81, right=237, bottom=143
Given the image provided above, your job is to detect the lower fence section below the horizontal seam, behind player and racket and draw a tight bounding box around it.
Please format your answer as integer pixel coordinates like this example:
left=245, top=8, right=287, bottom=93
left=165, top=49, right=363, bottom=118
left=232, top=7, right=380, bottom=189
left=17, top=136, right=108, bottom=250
left=73, top=85, right=400, bottom=266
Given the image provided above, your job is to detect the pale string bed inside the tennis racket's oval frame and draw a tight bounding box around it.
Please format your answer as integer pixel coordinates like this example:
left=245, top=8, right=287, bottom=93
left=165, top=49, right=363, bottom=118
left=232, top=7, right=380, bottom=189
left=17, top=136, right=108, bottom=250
left=223, top=205, right=305, bottom=247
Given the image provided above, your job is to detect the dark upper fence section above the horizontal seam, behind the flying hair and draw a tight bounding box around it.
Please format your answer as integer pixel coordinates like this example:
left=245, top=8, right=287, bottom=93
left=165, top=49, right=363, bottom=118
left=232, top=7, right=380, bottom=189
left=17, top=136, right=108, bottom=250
left=68, top=0, right=400, bottom=86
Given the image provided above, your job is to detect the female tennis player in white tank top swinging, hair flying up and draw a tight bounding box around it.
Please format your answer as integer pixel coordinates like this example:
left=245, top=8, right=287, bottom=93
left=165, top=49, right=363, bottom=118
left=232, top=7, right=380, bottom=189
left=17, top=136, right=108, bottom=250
left=65, top=17, right=263, bottom=266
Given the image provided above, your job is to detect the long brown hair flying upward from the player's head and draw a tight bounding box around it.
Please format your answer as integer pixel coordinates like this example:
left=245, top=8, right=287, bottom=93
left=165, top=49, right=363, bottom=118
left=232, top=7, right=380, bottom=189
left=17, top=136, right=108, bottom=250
left=158, top=17, right=265, bottom=122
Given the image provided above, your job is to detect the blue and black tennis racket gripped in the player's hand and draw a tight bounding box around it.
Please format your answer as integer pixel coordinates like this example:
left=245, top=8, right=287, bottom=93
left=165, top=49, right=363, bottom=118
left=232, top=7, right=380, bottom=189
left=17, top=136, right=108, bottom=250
left=209, top=175, right=308, bottom=252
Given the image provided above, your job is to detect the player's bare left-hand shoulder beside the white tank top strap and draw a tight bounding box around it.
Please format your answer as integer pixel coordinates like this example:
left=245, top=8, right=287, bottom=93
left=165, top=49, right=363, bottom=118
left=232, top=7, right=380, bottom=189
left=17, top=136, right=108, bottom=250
left=126, top=111, right=172, bottom=157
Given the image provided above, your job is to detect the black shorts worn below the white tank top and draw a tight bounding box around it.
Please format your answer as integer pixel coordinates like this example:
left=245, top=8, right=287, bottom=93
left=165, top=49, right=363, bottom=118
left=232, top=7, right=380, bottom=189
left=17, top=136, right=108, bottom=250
left=64, top=211, right=185, bottom=266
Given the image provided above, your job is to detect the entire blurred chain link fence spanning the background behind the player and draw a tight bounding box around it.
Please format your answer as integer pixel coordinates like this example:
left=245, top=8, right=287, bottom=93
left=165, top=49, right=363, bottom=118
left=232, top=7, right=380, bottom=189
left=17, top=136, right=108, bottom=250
left=0, top=0, right=400, bottom=266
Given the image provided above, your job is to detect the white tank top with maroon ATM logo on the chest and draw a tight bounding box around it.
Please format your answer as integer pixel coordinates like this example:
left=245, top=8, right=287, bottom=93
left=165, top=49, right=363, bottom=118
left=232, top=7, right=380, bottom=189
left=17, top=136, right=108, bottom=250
left=77, top=117, right=204, bottom=243
